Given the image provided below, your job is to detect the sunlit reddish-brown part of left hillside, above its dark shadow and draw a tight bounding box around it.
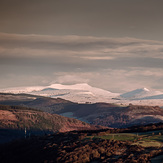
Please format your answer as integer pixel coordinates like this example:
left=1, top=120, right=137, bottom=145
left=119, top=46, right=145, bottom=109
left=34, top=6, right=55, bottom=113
left=0, top=105, right=98, bottom=132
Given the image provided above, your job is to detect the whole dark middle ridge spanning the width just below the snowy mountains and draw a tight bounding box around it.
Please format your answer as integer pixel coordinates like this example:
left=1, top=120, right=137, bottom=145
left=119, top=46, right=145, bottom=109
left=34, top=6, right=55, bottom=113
left=0, top=94, right=163, bottom=128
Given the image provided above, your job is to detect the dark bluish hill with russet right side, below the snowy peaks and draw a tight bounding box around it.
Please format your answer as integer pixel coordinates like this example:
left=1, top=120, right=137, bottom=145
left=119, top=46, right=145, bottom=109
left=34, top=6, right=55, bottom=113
left=62, top=103, right=163, bottom=128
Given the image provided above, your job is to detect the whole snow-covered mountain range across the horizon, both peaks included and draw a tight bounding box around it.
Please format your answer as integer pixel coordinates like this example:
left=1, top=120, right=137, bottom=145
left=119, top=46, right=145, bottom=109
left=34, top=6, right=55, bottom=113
left=0, top=83, right=163, bottom=106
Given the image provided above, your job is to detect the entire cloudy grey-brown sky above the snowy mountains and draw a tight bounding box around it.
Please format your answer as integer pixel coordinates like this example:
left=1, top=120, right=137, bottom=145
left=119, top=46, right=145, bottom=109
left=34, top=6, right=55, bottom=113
left=0, top=0, right=163, bottom=92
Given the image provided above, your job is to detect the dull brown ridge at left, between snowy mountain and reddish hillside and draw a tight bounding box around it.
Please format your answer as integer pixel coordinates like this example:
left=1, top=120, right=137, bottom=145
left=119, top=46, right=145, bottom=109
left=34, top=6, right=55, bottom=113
left=0, top=93, right=77, bottom=113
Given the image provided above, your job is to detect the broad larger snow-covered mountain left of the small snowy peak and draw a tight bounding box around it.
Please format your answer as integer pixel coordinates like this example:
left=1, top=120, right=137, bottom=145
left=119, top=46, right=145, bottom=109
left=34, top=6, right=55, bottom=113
left=0, top=83, right=119, bottom=103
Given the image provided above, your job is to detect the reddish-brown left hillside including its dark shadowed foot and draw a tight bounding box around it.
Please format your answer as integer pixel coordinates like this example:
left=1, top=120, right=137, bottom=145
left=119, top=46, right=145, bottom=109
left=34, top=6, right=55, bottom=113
left=0, top=105, right=99, bottom=143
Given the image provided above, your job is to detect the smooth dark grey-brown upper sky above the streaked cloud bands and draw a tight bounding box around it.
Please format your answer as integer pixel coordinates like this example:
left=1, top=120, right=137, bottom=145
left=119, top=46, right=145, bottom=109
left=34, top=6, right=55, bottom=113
left=0, top=0, right=163, bottom=40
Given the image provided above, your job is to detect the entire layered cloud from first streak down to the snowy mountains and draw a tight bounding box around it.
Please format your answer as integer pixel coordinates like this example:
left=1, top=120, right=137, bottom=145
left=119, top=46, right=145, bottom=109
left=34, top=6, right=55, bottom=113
left=0, top=33, right=163, bottom=91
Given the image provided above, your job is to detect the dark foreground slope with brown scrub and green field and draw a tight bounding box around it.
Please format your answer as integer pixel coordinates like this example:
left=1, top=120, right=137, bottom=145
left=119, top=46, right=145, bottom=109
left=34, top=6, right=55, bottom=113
left=0, top=123, right=163, bottom=163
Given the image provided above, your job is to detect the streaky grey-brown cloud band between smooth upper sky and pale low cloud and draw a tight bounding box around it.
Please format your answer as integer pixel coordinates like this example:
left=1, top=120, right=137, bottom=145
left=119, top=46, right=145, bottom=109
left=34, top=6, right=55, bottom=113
left=0, top=33, right=163, bottom=71
